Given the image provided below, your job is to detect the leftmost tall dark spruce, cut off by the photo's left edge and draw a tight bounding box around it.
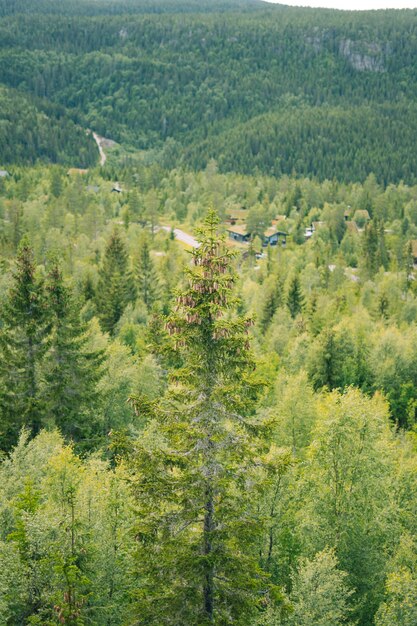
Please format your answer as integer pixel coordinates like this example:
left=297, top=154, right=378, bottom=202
left=0, top=237, right=47, bottom=449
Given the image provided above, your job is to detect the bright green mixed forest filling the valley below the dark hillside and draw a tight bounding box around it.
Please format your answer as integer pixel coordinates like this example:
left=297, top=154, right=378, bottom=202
left=0, top=161, right=417, bottom=626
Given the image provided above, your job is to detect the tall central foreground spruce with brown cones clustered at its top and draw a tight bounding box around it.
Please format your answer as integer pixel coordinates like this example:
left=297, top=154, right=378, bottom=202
left=128, top=212, right=278, bottom=626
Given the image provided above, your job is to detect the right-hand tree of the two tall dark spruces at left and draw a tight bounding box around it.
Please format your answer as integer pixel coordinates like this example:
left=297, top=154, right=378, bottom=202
left=42, top=261, right=104, bottom=443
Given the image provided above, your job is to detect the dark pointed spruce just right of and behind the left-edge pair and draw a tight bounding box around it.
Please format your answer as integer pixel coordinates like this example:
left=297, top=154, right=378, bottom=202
left=96, top=230, right=135, bottom=334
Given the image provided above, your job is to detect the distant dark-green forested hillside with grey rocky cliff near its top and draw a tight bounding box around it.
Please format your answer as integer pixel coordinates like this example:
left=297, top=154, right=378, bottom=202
left=0, top=0, right=417, bottom=184
